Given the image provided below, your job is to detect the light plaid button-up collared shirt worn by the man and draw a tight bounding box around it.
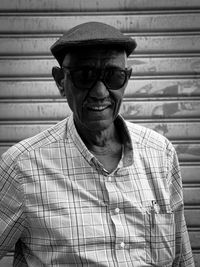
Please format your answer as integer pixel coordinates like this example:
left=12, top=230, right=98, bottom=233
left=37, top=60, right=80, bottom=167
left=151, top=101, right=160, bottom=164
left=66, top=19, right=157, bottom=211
left=0, top=116, right=194, bottom=267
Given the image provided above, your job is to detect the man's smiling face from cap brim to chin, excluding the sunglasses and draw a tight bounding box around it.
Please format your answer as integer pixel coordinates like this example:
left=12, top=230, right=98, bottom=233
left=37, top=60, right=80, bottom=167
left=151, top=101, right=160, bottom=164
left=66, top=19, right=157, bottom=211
left=63, top=49, right=127, bottom=131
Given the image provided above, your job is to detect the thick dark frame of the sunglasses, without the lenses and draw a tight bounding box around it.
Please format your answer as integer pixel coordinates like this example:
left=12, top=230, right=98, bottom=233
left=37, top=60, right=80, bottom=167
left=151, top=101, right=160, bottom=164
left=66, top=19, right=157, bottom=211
left=62, top=66, right=132, bottom=90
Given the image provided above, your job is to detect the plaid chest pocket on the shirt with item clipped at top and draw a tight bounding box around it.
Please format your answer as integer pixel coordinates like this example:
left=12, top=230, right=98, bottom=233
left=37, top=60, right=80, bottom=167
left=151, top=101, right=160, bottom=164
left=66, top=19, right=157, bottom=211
left=145, top=201, right=175, bottom=267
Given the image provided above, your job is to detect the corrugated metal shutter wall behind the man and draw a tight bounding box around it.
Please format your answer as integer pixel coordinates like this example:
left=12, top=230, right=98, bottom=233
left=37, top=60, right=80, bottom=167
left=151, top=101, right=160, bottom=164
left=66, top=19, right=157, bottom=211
left=0, top=0, right=200, bottom=267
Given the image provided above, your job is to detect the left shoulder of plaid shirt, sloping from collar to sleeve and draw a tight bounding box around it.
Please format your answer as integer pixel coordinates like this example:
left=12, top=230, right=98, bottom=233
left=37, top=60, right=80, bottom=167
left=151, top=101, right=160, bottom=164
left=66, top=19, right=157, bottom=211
left=3, top=118, right=68, bottom=164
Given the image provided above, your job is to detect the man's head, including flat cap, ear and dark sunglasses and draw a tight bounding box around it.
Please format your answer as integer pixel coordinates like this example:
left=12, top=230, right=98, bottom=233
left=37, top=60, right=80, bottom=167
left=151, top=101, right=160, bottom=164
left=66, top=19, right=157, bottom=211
left=51, top=22, right=136, bottom=130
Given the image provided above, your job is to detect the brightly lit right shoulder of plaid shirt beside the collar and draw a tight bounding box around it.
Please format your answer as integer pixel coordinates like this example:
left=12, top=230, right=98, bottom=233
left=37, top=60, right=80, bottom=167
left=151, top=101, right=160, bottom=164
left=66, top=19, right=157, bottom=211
left=126, top=121, right=172, bottom=150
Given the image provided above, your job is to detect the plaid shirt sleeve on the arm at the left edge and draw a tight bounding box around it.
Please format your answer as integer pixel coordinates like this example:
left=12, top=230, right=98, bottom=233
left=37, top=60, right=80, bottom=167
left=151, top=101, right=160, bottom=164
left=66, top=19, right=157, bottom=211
left=0, top=152, right=25, bottom=258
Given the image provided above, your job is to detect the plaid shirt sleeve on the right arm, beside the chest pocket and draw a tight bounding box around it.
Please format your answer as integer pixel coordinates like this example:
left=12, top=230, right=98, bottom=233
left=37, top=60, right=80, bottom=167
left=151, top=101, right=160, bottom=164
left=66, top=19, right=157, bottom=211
left=169, top=144, right=195, bottom=267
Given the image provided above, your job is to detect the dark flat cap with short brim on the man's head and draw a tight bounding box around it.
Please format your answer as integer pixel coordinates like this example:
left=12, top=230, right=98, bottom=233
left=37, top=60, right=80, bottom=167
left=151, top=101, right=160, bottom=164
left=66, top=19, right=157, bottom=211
left=51, top=22, right=136, bottom=65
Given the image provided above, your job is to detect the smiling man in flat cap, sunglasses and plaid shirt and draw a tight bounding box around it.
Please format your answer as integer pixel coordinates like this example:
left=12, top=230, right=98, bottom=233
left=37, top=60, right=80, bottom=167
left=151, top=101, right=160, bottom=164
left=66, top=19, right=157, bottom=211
left=0, top=22, right=194, bottom=267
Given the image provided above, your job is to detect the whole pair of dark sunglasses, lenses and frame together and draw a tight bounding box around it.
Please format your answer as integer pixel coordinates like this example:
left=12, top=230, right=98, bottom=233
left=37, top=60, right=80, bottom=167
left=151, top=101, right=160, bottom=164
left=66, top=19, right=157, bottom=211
left=63, top=67, right=132, bottom=90
